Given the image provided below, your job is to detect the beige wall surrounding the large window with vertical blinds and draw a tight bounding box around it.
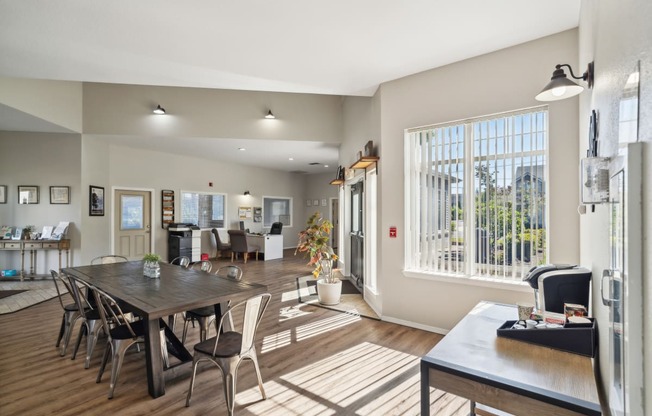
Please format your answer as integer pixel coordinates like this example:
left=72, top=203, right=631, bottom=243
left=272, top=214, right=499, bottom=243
left=378, top=30, right=579, bottom=330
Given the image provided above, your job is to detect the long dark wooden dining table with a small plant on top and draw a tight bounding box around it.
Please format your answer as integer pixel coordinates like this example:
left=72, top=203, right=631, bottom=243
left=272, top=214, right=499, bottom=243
left=62, top=261, right=267, bottom=398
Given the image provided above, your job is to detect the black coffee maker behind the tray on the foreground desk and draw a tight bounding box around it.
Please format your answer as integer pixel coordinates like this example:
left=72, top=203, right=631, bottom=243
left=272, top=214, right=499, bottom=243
left=523, top=264, right=591, bottom=313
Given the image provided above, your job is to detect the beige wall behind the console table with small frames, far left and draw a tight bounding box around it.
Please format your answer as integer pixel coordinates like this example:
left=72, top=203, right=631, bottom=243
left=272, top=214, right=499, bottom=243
left=0, top=131, right=86, bottom=273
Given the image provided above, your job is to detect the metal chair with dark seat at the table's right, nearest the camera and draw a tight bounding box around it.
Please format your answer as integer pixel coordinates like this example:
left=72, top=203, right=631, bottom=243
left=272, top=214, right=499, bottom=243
left=186, top=293, right=272, bottom=416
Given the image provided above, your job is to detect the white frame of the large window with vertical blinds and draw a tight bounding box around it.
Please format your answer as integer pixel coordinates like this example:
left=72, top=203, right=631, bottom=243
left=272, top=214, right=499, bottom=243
left=403, top=106, right=550, bottom=291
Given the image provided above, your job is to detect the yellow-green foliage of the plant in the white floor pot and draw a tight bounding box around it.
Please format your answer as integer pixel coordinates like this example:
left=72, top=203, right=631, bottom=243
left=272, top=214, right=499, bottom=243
left=294, top=212, right=337, bottom=283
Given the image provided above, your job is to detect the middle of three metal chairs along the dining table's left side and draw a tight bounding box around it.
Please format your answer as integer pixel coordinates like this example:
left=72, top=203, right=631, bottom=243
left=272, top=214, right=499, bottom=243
left=68, top=275, right=102, bottom=368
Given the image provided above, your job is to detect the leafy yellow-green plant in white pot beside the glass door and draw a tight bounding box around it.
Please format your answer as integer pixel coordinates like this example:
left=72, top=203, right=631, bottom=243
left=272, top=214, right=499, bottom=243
left=294, top=212, right=342, bottom=305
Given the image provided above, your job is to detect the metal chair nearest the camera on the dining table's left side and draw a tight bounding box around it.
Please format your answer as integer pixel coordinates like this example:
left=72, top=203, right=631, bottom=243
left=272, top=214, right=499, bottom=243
left=89, top=286, right=170, bottom=399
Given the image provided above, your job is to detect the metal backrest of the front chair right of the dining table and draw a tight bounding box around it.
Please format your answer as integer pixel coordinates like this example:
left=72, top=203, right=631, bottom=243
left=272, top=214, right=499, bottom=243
left=213, top=293, right=272, bottom=355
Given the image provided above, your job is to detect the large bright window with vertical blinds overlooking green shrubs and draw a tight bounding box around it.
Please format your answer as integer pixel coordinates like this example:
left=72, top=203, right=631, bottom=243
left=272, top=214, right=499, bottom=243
left=405, top=107, right=548, bottom=281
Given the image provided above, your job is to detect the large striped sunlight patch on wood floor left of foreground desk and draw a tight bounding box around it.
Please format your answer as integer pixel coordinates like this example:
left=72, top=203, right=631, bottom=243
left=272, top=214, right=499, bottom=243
left=238, top=342, right=420, bottom=415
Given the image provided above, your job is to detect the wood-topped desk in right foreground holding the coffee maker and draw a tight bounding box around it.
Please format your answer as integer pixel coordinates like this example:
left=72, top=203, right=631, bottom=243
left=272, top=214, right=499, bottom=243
left=421, top=302, right=601, bottom=416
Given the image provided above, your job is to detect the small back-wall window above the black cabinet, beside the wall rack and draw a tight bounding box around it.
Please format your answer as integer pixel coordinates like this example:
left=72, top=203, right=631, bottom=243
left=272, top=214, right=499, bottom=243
left=181, top=191, right=226, bottom=228
